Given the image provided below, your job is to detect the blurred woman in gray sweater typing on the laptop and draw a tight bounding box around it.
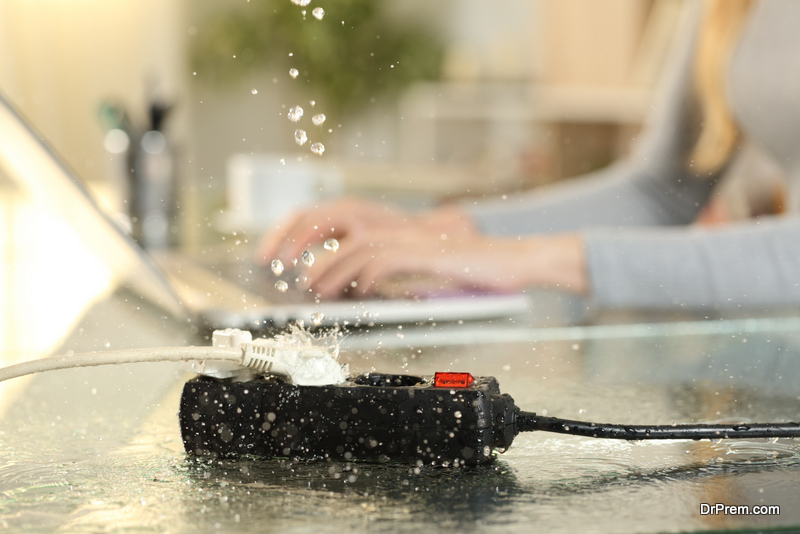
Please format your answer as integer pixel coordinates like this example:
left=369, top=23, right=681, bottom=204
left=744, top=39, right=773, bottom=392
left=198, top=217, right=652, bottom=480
left=258, top=0, right=800, bottom=308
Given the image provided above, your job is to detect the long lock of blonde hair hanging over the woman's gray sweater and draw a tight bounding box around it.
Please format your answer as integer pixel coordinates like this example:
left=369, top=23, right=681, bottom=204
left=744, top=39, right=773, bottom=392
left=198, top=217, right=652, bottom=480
left=689, top=0, right=752, bottom=174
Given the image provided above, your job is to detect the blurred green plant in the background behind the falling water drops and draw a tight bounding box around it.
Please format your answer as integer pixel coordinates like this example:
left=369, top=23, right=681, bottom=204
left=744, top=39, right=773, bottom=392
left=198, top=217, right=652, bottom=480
left=193, top=0, right=443, bottom=118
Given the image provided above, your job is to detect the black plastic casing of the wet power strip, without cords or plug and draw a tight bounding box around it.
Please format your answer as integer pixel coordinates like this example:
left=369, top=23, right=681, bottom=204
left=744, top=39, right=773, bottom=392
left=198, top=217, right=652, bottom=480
left=179, top=373, right=517, bottom=465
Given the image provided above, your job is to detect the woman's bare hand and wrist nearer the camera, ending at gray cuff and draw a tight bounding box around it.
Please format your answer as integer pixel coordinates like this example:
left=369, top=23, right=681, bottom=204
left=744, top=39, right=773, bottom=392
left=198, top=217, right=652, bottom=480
left=306, top=230, right=588, bottom=298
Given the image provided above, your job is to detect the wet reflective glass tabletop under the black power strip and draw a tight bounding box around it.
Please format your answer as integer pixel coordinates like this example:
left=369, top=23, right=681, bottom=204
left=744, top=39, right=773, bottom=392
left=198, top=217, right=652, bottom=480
left=0, top=310, right=800, bottom=533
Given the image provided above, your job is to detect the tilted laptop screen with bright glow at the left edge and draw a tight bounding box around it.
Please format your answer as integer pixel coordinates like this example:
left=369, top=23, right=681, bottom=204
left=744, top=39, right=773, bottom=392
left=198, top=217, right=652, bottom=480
left=0, top=90, right=187, bottom=356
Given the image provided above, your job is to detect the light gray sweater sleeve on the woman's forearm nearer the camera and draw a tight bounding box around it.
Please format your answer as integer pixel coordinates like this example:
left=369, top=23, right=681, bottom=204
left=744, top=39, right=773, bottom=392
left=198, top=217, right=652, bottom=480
left=584, top=217, right=800, bottom=308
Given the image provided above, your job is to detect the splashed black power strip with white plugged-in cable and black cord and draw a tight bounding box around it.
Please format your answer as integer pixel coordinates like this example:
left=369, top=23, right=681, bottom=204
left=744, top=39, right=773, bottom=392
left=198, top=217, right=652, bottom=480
left=0, top=329, right=800, bottom=465
